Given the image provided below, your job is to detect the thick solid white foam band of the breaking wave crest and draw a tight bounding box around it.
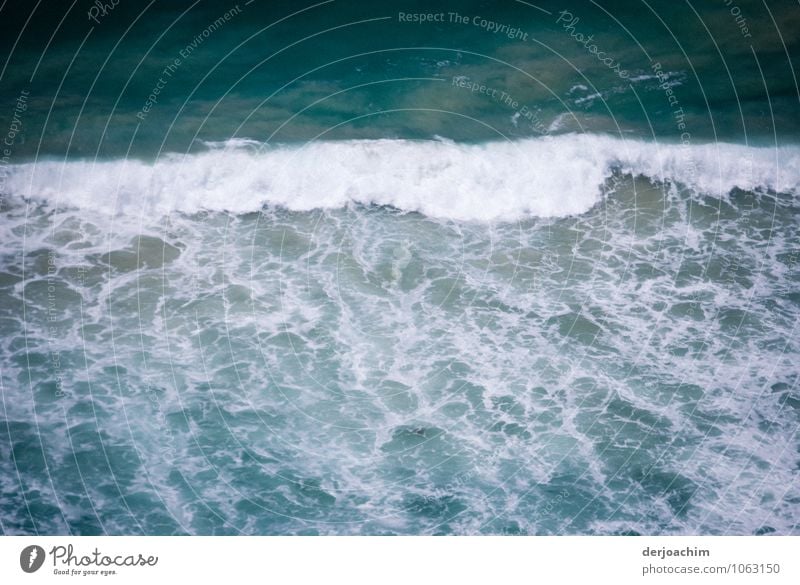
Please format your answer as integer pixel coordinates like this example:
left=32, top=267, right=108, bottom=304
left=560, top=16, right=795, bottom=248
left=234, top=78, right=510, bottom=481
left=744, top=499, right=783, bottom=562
left=5, top=134, right=800, bottom=221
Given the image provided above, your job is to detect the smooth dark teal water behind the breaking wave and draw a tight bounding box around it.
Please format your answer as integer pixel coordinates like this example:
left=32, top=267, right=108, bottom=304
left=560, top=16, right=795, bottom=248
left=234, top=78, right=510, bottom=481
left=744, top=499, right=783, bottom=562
left=0, top=1, right=800, bottom=157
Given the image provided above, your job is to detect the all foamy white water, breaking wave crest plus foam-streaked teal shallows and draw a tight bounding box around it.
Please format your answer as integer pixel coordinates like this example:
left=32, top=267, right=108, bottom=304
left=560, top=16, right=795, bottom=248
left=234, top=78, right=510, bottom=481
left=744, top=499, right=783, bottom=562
left=0, top=135, right=800, bottom=534
